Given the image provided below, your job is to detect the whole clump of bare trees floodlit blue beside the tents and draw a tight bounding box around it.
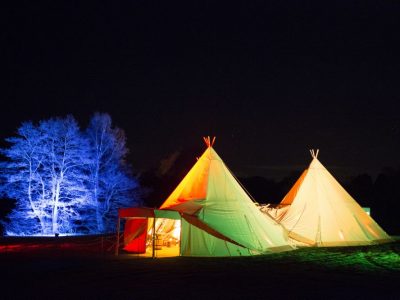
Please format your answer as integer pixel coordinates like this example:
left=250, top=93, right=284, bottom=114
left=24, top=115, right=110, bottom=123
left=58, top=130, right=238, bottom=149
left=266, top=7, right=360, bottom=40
left=1, top=114, right=138, bottom=235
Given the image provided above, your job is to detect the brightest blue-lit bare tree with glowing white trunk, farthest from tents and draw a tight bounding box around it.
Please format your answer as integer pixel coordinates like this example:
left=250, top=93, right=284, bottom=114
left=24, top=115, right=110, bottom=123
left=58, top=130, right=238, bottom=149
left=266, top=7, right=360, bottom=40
left=2, top=116, right=93, bottom=235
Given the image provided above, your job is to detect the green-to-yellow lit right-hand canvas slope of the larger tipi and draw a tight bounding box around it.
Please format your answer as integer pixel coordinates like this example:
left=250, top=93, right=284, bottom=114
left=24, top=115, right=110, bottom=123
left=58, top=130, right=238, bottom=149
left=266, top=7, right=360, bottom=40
left=198, top=149, right=291, bottom=253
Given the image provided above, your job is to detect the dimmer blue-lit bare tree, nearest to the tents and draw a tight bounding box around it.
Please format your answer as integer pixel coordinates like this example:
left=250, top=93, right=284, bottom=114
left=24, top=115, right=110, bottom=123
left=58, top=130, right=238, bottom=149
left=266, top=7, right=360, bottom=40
left=86, top=113, right=138, bottom=232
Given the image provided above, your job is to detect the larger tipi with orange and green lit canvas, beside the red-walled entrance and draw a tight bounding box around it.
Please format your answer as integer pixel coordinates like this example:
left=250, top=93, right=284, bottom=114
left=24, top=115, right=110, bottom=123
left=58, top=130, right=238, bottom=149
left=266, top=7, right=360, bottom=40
left=120, top=138, right=293, bottom=256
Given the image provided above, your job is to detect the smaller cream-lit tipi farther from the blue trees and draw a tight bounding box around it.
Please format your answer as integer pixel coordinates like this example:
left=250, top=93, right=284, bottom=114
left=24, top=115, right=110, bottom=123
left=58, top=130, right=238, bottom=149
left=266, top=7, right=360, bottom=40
left=261, top=150, right=391, bottom=247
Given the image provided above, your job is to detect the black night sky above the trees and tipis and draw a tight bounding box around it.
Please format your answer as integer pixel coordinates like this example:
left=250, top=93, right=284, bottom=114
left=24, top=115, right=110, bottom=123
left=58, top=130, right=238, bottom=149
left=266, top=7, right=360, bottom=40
left=0, top=1, right=400, bottom=179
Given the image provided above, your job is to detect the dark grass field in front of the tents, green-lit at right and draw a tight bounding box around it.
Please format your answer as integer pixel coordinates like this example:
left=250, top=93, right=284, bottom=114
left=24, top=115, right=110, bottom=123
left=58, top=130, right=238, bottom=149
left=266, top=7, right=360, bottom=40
left=0, top=241, right=400, bottom=300
